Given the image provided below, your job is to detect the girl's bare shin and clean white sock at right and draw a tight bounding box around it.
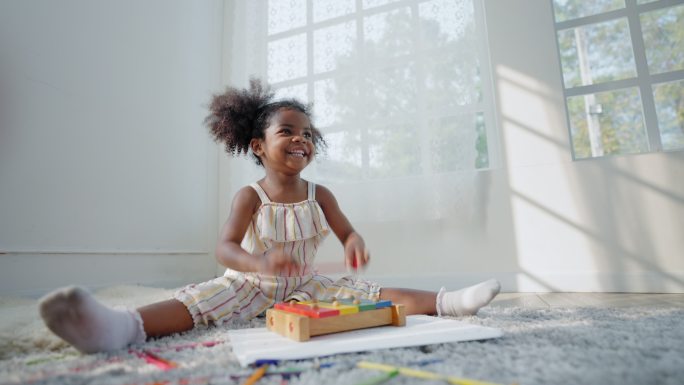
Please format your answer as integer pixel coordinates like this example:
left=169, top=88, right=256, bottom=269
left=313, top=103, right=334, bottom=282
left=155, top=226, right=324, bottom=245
left=380, top=279, right=501, bottom=316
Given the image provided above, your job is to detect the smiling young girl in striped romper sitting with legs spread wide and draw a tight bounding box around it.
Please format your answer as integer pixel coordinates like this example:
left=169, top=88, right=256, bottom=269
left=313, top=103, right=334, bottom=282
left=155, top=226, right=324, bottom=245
left=40, top=80, right=499, bottom=353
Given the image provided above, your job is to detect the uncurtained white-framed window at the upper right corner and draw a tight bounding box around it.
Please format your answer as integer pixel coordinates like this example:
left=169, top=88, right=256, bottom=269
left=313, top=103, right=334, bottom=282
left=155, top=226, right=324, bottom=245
left=552, top=0, right=684, bottom=159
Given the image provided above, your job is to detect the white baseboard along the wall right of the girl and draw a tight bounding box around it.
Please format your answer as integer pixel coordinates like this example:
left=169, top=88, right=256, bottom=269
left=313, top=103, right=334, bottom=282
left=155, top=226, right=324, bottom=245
left=364, top=271, right=684, bottom=293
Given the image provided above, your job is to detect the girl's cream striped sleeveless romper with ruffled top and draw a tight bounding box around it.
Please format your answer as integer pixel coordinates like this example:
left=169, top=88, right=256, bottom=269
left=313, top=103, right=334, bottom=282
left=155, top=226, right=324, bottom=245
left=174, top=182, right=380, bottom=326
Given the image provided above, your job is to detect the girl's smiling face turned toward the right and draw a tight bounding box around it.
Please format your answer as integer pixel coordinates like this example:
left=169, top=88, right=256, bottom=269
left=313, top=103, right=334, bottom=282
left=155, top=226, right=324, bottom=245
left=251, top=108, right=316, bottom=174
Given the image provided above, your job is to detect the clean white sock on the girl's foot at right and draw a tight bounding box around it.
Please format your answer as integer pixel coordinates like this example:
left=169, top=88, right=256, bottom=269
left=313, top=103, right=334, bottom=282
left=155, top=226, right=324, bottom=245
left=436, top=279, right=501, bottom=317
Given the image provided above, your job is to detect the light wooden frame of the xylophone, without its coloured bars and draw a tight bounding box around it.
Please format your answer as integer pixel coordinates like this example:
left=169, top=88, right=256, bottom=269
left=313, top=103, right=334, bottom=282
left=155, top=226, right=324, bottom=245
left=266, top=304, right=406, bottom=342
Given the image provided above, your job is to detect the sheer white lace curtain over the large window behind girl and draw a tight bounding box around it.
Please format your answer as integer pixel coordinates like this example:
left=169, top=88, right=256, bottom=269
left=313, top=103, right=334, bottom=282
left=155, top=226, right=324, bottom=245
left=226, top=0, right=498, bottom=226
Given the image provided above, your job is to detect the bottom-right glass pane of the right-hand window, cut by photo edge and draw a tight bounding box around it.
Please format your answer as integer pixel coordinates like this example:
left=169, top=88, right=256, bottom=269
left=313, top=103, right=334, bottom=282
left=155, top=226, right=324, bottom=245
left=653, top=81, right=684, bottom=150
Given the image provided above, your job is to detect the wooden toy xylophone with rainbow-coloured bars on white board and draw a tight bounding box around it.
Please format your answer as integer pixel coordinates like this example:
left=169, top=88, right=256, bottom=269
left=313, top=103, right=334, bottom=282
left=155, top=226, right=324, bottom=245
left=266, top=297, right=406, bottom=342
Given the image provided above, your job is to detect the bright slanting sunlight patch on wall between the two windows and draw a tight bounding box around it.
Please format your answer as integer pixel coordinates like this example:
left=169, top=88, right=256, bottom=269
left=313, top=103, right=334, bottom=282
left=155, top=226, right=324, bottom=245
left=496, top=66, right=597, bottom=290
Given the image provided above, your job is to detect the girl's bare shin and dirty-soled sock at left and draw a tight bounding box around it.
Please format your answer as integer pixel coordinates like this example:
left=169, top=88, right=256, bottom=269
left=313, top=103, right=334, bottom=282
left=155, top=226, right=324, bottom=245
left=39, top=287, right=193, bottom=353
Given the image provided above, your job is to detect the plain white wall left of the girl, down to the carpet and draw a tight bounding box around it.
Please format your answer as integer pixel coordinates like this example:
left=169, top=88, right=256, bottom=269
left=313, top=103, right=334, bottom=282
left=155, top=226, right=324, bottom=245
left=0, top=0, right=223, bottom=294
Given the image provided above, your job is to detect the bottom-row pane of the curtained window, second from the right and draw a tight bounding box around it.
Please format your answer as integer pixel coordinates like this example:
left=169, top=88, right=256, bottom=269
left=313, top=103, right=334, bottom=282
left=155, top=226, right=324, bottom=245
left=368, top=123, right=422, bottom=178
